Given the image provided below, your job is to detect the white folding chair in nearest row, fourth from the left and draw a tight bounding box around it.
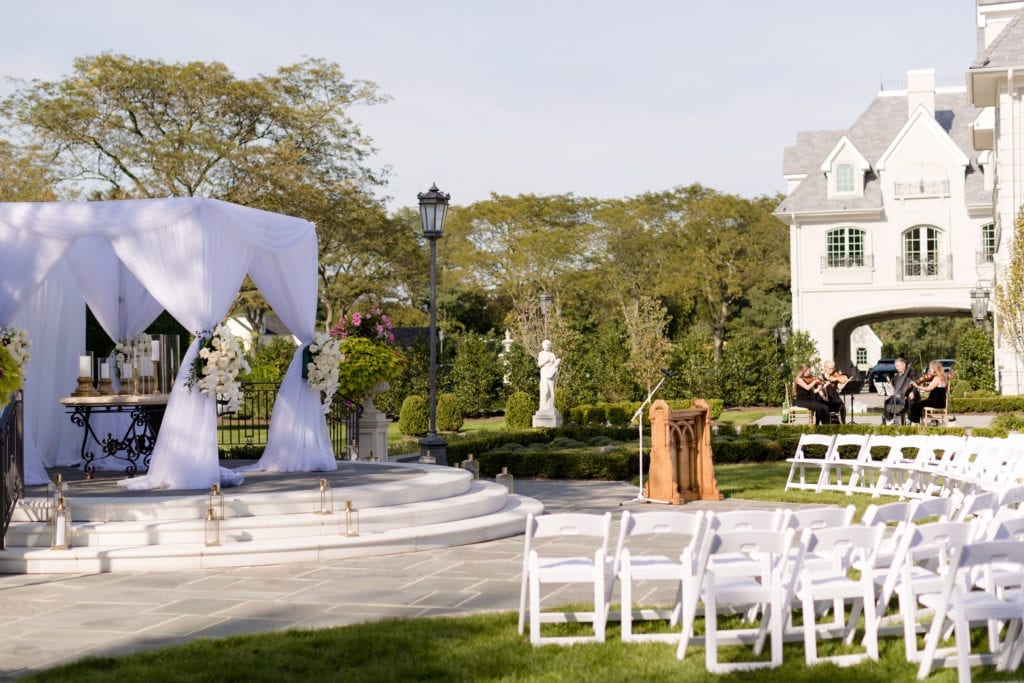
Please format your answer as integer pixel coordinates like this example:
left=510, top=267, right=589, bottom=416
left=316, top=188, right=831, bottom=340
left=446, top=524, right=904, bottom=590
left=797, top=526, right=885, bottom=667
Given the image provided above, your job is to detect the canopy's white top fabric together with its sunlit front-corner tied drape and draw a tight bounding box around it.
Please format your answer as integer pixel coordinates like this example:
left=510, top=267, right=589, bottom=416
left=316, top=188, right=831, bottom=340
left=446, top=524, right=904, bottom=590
left=0, top=198, right=316, bottom=488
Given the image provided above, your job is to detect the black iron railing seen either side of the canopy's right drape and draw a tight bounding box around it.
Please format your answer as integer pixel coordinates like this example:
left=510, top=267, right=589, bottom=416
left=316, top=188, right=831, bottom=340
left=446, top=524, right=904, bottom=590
left=217, top=382, right=362, bottom=458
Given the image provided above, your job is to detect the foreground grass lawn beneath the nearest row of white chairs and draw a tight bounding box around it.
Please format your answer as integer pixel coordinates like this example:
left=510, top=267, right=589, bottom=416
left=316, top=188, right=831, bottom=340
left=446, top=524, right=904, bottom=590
left=24, top=612, right=1018, bottom=683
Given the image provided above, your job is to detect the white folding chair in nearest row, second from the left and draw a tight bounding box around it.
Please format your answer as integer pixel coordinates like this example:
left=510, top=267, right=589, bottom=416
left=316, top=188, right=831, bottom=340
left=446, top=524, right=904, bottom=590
left=608, top=510, right=707, bottom=642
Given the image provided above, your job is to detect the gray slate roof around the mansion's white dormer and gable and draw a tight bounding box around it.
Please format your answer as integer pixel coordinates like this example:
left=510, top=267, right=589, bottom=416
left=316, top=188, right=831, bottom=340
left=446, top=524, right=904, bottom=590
left=775, top=89, right=987, bottom=214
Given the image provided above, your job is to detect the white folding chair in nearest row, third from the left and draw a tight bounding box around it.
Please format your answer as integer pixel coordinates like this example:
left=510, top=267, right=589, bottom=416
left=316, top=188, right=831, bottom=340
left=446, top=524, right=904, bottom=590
left=676, top=529, right=803, bottom=673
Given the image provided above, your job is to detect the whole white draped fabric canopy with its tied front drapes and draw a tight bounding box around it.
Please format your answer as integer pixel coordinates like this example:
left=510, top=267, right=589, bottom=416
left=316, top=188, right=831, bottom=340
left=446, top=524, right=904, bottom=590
left=0, top=198, right=336, bottom=488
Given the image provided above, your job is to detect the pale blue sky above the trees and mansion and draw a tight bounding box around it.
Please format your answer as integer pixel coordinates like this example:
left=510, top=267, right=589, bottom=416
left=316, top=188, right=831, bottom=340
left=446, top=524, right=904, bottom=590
left=0, top=0, right=976, bottom=207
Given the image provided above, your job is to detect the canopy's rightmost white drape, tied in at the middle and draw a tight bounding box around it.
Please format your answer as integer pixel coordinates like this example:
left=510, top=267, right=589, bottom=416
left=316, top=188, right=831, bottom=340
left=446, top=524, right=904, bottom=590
left=249, top=233, right=338, bottom=472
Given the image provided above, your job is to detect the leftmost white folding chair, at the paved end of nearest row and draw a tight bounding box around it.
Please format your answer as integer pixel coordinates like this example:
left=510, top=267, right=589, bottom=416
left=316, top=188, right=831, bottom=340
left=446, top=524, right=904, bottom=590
left=519, top=512, right=611, bottom=645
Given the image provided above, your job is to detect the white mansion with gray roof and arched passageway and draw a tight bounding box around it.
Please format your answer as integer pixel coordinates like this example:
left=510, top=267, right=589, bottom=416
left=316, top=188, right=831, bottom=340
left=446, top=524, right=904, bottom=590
left=775, top=0, right=1024, bottom=393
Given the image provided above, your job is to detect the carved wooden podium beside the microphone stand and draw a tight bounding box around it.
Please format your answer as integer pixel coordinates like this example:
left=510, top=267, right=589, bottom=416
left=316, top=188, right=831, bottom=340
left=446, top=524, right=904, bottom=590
left=644, top=398, right=723, bottom=505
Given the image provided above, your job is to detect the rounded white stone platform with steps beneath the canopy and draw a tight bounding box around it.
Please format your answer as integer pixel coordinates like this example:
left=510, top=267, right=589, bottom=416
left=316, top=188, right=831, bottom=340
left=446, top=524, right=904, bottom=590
left=0, top=461, right=544, bottom=573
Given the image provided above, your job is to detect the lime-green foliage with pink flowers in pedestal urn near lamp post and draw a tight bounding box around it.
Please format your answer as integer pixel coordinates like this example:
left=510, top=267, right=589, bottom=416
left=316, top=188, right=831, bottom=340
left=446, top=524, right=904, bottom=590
left=331, top=308, right=406, bottom=399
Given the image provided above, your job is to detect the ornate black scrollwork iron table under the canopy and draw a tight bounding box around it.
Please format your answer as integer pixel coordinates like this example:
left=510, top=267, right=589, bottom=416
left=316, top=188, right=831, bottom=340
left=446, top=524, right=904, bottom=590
left=60, top=394, right=168, bottom=475
